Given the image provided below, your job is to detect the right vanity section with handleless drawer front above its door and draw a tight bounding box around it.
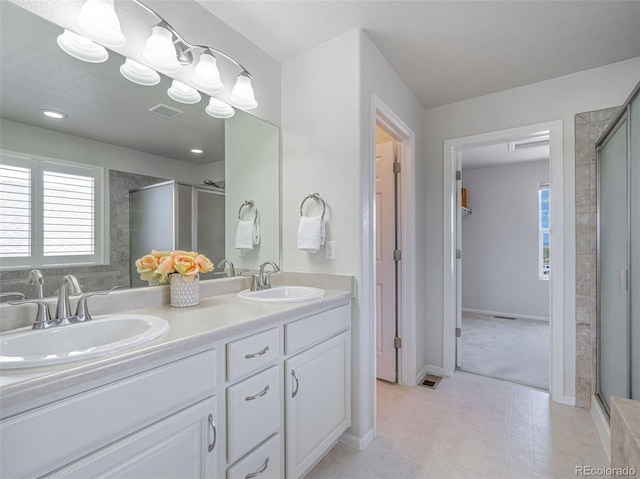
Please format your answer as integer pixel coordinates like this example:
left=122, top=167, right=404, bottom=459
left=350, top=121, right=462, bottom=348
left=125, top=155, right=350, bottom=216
left=285, top=306, right=351, bottom=479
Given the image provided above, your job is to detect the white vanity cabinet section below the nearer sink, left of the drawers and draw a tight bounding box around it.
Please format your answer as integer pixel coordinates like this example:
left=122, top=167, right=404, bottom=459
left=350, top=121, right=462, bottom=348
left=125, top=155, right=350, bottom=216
left=0, top=350, right=220, bottom=479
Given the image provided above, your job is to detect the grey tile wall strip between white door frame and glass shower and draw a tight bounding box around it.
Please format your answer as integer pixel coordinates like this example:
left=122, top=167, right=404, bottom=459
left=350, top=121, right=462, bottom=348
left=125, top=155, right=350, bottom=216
left=575, top=107, right=620, bottom=409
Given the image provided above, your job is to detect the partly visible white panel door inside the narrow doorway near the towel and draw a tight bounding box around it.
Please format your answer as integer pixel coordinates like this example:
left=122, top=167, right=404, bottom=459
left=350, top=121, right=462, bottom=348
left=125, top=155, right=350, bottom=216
left=375, top=142, right=397, bottom=382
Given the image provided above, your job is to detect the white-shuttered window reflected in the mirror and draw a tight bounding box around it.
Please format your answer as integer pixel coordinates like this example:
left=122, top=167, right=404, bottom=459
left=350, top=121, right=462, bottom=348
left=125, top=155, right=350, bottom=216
left=0, top=152, right=104, bottom=269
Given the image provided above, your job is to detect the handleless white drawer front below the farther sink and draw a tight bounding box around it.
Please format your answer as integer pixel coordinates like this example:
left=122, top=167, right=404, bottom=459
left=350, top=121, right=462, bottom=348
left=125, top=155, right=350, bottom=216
left=284, top=305, right=351, bottom=354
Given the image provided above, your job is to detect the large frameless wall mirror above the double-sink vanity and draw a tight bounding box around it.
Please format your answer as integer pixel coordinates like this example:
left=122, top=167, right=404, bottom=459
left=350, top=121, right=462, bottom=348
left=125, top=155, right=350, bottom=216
left=0, top=0, right=280, bottom=297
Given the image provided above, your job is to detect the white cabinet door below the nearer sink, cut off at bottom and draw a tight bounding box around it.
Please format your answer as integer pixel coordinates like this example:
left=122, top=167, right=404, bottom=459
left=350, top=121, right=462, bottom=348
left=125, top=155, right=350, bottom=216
left=45, top=397, right=223, bottom=479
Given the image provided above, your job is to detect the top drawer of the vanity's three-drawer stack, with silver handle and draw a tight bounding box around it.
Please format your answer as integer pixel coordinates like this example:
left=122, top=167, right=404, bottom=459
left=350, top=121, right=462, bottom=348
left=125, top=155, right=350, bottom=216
left=227, top=328, right=280, bottom=381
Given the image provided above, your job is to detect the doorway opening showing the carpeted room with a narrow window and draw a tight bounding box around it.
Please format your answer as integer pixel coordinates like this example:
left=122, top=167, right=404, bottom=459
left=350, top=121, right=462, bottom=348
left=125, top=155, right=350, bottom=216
left=456, top=137, right=551, bottom=390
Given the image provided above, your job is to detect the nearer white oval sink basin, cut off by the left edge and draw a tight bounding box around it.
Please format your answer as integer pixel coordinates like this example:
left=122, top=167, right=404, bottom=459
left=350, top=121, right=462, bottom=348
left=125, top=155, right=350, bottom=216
left=0, top=314, right=169, bottom=369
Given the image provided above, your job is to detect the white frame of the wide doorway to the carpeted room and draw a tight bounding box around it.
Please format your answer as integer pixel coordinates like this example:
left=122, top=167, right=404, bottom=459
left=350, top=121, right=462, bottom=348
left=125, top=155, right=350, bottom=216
left=442, top=120, right=575, bottom=405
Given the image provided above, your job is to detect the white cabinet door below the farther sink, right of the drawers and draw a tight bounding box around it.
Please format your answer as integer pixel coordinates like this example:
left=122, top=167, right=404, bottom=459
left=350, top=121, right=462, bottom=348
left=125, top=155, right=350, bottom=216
left=285, top=331, right=351, bottom=479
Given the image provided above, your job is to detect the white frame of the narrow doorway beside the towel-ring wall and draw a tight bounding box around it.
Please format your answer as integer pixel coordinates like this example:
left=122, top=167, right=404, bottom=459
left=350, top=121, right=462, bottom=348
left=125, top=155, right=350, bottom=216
left=363, top=93, right=419, bottom=390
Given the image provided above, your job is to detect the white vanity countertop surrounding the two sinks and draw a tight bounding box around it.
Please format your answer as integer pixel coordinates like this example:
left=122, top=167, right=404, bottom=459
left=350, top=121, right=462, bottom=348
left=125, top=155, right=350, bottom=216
left=0, top=290, right=351, bottom=417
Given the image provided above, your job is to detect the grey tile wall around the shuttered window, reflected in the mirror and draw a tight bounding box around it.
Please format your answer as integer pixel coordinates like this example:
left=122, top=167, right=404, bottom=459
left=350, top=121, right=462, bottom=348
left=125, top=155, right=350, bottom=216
left=0, top=170, right=167, bottom=298
